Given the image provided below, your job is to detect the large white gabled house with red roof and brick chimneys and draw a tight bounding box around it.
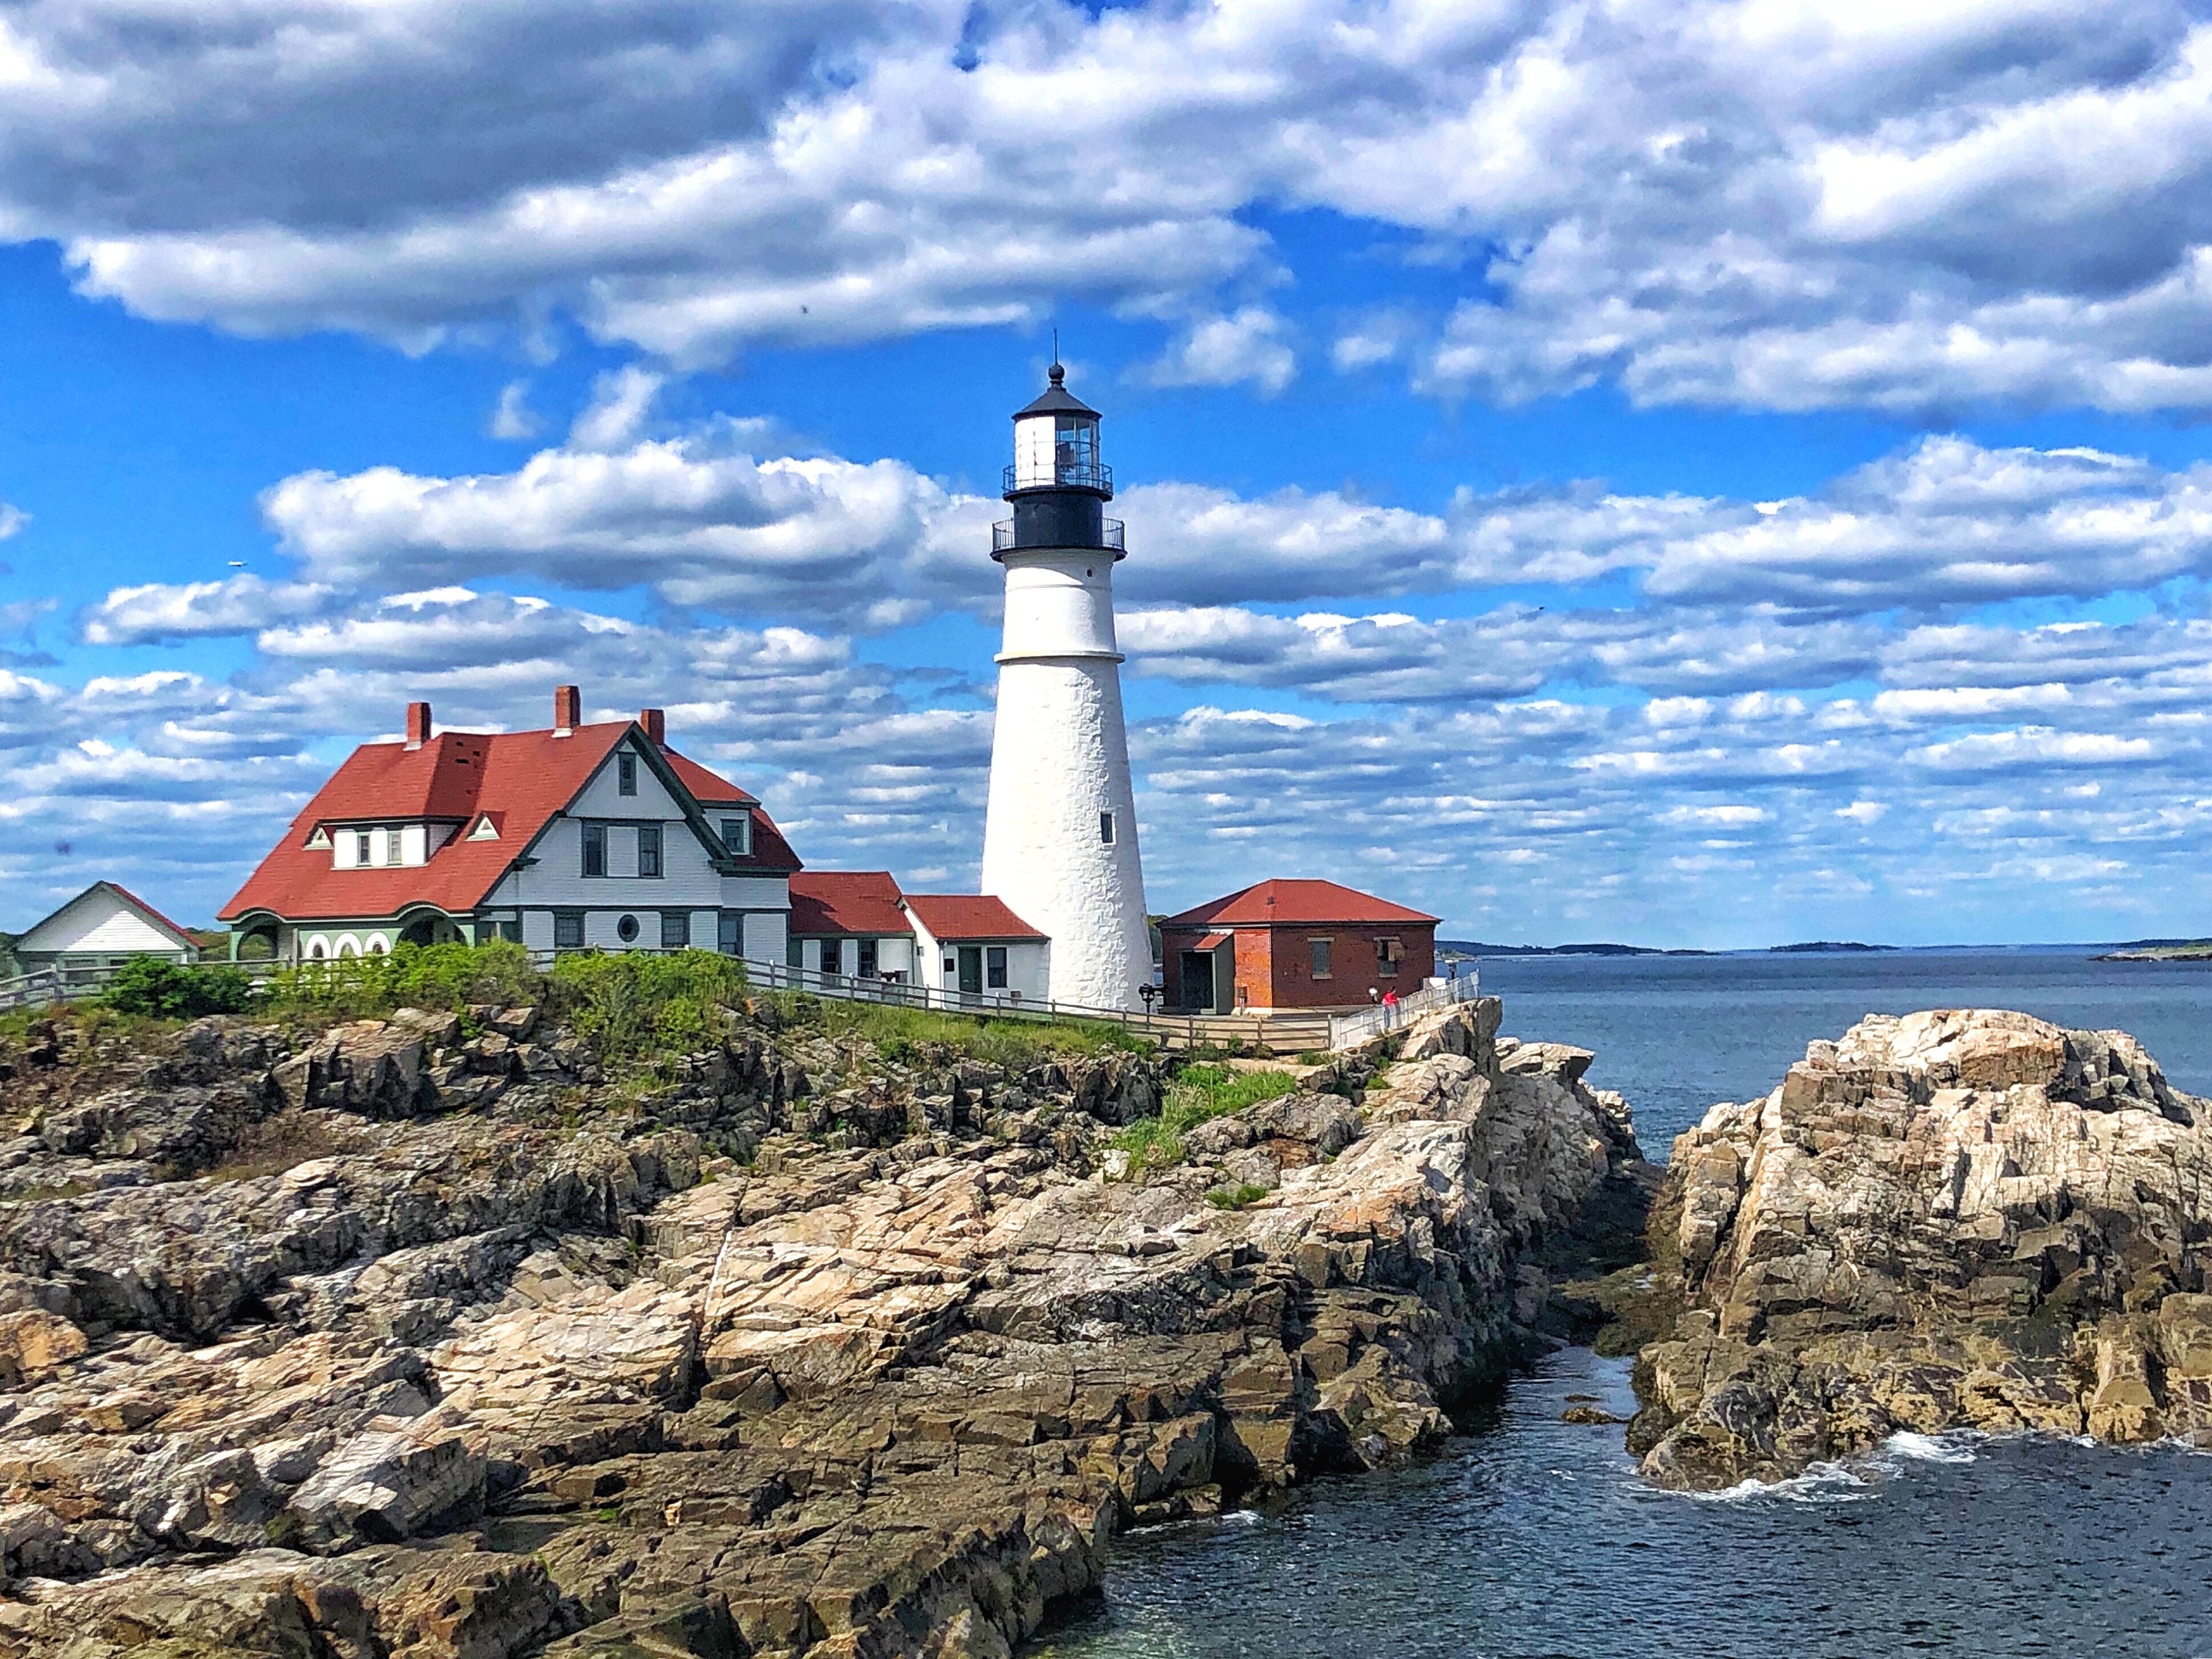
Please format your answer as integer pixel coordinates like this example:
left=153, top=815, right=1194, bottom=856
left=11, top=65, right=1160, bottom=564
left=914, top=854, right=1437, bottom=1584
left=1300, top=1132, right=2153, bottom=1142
left=221, top=685, right=798, bottom=962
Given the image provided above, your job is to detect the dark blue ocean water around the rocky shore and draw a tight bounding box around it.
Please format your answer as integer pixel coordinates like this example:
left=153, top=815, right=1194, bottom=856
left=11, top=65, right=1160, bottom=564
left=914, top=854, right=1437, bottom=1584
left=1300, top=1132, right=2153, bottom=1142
left=1037, top=951, right=2212, bottom=1659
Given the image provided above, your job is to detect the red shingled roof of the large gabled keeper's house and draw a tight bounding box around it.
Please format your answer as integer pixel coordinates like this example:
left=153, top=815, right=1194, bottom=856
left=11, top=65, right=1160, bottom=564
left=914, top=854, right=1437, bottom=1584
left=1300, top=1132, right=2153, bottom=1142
left=217, top=721, right=798, bottom=922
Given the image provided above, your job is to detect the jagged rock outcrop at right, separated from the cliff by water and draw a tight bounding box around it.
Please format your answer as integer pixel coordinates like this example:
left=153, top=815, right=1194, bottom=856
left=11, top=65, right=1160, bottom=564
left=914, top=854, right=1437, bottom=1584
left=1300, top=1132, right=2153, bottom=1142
left=1630, top=1011, right=2212, bottom=1488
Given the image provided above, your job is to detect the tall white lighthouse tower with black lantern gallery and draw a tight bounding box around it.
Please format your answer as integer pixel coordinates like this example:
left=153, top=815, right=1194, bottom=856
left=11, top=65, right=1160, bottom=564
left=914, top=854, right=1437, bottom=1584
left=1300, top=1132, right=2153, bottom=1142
left=982, top=363, right=1153, bottom=1009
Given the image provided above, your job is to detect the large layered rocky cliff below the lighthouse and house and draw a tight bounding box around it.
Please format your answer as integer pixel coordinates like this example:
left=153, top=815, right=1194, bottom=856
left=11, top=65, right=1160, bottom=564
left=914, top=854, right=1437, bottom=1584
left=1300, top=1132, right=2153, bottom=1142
left=0, top=1002, right=1641, bottom=1659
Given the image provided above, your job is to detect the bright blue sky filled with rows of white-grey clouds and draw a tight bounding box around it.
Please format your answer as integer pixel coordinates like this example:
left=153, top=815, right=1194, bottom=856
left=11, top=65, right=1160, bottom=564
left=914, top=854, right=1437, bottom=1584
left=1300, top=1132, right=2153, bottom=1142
left=0, top=0, right=2212, bottom=947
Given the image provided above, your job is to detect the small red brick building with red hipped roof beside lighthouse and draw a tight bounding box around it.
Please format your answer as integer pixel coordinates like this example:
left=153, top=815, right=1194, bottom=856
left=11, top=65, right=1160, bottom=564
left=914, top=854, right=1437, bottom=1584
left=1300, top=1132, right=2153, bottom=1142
left=1159, top=880, right=1435, bottom=1013
